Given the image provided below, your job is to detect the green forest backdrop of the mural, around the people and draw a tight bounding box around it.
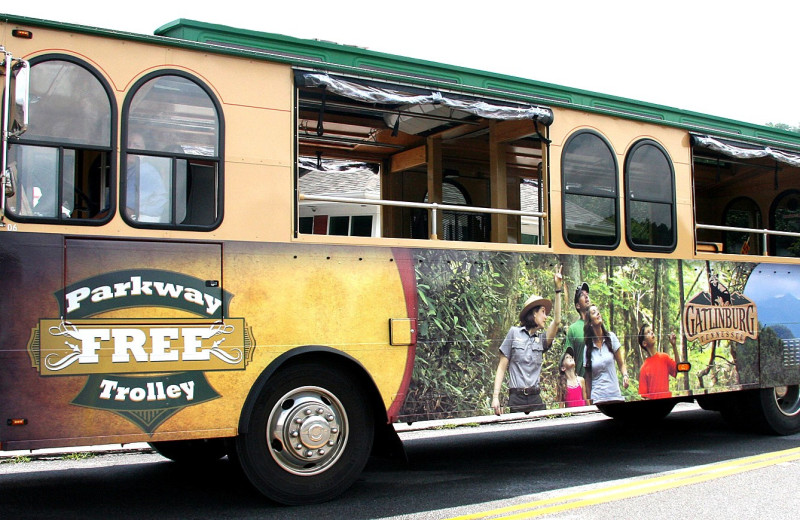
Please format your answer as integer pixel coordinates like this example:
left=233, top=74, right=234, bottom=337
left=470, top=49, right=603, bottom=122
left=401, top=250, right=788, bottom=419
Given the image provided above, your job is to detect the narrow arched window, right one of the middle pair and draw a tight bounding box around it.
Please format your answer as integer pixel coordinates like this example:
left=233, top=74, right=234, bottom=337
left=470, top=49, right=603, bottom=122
left=625, top=139, right=677, bottom=251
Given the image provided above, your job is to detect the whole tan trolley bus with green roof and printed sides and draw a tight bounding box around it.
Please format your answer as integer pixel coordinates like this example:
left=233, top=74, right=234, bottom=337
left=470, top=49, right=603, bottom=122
left=0, top=15, right=800, bottom=504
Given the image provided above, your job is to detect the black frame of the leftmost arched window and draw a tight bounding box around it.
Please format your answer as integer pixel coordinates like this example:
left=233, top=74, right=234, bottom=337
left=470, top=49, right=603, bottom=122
left=5, top=53, right=119, bottom=226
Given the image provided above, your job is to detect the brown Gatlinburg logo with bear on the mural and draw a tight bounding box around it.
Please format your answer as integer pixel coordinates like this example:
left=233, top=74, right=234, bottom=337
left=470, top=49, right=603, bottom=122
left=683, top=275, right=758, bottom=344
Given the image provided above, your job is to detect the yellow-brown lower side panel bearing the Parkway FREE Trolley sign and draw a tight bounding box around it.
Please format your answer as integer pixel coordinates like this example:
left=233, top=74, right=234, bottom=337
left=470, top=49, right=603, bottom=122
left=0, top=234, right=416, bottom=449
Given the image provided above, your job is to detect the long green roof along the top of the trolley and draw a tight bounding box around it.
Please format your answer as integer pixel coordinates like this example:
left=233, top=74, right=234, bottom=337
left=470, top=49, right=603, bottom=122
left=0, top=14, right=800, bottom=150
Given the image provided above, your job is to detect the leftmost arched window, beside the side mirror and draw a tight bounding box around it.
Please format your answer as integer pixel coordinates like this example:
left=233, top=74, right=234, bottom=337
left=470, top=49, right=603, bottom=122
left=7, top=54, right=116, bottom=225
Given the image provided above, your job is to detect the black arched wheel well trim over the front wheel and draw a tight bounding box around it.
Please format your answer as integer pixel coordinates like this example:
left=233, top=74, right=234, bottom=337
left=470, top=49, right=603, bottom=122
left=239, top=346, right=392, bottom=450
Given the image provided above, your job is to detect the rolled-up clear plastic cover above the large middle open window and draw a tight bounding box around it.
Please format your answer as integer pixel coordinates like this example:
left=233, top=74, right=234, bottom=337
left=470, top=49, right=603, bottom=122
left=302, top=73, right=553, bottom=126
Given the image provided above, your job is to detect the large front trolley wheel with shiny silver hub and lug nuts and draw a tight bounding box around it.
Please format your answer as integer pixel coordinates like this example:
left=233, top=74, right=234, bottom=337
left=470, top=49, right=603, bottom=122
left=236, top=364, right=374, bottom=505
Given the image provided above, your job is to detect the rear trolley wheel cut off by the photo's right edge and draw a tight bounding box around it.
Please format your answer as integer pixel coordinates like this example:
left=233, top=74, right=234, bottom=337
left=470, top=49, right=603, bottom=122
left=748, top=385, right=800, bottom=435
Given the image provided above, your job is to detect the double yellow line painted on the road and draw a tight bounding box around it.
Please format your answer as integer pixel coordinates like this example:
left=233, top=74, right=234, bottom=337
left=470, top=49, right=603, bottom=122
left=450, top=448, right=800, bottom=520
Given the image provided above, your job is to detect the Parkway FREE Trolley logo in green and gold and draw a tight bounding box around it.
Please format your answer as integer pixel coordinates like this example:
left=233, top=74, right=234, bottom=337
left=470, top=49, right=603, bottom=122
left=28, top=269, right=255, bottom=433
